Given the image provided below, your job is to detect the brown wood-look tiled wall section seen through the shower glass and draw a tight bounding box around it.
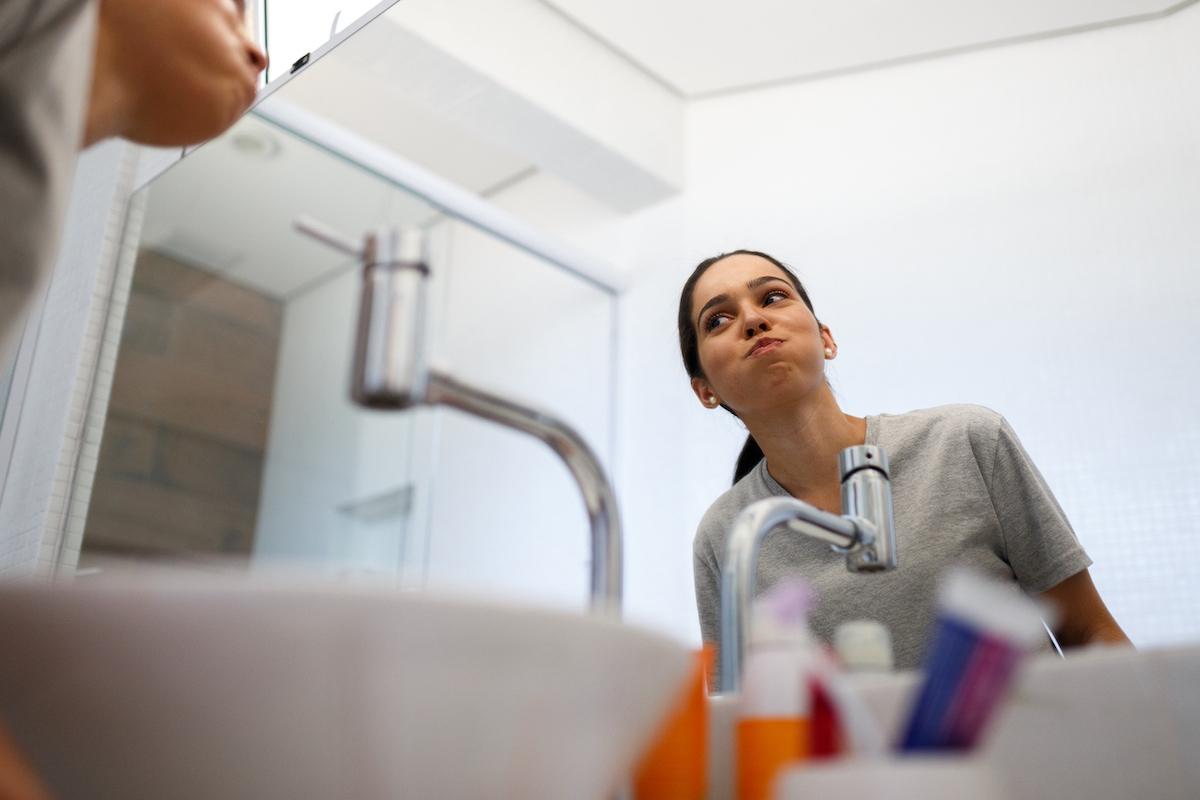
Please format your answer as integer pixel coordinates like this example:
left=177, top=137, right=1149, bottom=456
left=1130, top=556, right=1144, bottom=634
left=83, top=249, right=282, bottom=554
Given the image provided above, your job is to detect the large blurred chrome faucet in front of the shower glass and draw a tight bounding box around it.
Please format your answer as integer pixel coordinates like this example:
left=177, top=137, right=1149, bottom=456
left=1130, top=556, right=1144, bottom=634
left=295, top=217, right=622, bottom=616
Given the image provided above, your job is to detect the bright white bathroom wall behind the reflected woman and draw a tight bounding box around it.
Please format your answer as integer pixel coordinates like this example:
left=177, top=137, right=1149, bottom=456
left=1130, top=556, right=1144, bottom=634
left=472, top=7, right=1200, bottom=645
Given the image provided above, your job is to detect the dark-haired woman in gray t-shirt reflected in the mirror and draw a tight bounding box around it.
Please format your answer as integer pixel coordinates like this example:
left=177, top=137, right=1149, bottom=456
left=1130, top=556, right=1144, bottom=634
left=679, top=251, right=1128, bottom=669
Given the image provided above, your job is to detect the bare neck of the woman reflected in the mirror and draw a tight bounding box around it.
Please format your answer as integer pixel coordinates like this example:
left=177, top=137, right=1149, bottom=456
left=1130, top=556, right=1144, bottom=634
left=743, top=384, right=866, bottom=512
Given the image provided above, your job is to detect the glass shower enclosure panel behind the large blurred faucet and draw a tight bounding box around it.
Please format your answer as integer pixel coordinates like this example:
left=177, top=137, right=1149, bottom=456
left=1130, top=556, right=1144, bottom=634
left=80, top=110, right=613, bottom=606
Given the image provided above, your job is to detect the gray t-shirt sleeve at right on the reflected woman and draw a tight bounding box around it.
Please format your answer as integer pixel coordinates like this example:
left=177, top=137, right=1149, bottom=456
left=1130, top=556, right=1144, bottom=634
left=989, top=419, right=1092, bottom=594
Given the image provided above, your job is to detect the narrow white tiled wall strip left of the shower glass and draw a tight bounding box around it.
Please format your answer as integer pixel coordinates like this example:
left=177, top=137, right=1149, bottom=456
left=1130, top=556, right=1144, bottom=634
left=0, top=140, right=139, bottom=579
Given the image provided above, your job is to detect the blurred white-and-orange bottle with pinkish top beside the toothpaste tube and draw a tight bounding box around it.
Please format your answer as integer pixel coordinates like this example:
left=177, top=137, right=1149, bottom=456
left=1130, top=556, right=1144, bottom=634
left=734, top=582, right=816, bottom=800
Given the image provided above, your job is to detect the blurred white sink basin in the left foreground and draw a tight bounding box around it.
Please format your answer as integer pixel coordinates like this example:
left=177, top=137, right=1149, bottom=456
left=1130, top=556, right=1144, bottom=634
left=0, top=576, right=689, bottom=800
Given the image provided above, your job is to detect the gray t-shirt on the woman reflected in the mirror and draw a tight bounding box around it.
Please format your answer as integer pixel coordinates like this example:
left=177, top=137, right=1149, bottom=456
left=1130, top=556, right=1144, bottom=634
left=692, top=405, right=1092, bottom=669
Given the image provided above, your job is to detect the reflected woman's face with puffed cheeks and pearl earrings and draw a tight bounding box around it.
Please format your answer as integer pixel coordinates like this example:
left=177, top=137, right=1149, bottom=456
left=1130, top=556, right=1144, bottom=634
left=691, top=254, right=836, bottom=415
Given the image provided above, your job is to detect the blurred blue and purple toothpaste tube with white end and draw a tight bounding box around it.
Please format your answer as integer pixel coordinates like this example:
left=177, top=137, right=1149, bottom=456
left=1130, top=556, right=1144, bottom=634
left=900, top=570, right=1046, bottom=751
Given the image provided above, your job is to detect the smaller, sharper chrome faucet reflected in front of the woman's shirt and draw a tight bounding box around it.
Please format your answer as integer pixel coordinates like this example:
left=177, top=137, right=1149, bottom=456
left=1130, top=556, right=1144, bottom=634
left=720, top=445, right=896, bottom=693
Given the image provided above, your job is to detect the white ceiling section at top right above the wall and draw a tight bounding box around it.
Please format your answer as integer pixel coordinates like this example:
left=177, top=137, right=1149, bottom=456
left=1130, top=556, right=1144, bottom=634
left=540, top=0, right=1195, bottom=97
